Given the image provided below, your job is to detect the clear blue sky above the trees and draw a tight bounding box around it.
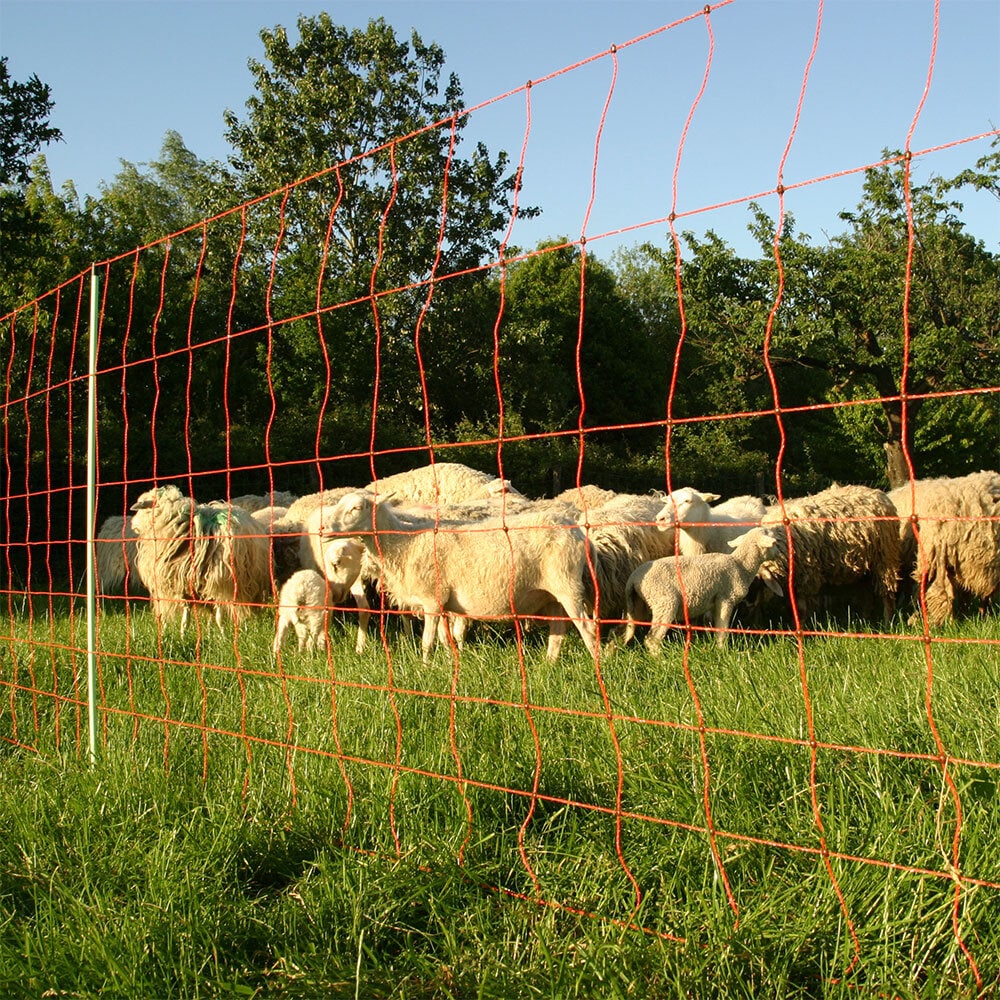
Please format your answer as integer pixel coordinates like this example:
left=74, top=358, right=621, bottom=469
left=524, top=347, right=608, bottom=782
left=0, top=0, right=1000, bottom=257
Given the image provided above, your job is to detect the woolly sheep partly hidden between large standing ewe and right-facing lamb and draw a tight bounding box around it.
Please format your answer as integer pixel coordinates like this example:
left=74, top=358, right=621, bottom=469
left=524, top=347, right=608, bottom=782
left=578, top=493, right=674, bottom=621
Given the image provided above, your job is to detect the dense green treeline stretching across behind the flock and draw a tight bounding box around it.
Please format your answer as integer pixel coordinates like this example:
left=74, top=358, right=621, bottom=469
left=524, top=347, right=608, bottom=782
left=0, top=14, right=1000, bottom=584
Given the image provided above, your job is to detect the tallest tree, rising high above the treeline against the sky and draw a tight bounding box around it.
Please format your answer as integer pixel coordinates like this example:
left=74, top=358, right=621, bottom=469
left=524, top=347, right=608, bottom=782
left=219, top=14, right=532, bottom=468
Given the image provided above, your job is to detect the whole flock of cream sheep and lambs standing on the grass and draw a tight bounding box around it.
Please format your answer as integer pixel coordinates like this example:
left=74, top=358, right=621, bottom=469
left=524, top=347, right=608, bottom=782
left=96, top=463, right=1000, bottom=660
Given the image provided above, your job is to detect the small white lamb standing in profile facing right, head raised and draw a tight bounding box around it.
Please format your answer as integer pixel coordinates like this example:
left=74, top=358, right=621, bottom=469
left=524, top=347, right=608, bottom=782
left=622, top=528, right=777, bottom=653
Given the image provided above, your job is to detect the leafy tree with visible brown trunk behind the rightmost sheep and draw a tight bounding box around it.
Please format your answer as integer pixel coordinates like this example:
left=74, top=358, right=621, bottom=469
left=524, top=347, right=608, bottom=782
left=804, top=153, right=1000, bottom=486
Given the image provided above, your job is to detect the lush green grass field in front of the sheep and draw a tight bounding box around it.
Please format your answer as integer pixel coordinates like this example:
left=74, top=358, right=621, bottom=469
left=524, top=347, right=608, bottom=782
left=0, top=603, right=1000, bottom=1000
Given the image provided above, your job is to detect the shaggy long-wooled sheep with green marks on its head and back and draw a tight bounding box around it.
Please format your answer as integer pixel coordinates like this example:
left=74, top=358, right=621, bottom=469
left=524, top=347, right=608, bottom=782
left=132, top=485, right=271, bottom=632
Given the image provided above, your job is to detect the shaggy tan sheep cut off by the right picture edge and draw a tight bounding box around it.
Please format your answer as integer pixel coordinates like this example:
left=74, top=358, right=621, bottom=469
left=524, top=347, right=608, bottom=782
left=889, top=470, right=1000, bottom=625
